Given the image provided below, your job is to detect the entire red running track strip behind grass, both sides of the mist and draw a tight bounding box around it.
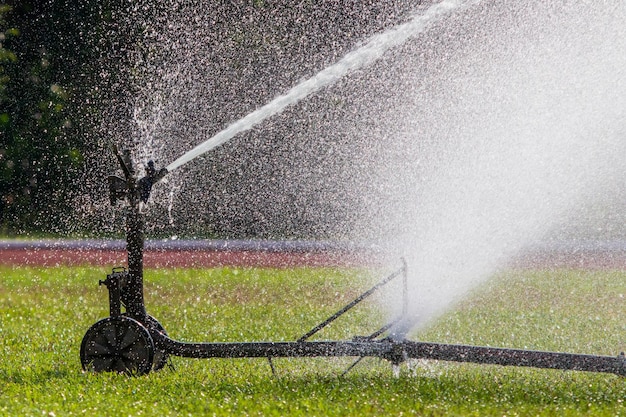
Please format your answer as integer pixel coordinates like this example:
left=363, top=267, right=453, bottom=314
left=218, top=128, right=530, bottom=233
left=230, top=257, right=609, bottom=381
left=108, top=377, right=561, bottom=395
left=0, top=240, right=626, bottom=269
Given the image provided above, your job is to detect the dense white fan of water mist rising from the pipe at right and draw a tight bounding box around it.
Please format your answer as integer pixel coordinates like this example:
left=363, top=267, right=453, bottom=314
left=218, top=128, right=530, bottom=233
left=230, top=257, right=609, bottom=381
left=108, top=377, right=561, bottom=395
left=366, top=2, right=626, bottom=333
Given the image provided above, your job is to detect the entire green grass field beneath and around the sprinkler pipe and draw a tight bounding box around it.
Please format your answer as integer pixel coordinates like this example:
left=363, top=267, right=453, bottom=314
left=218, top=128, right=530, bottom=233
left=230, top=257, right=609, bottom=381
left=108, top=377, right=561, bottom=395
left=0, top=267, right=626, bottom=416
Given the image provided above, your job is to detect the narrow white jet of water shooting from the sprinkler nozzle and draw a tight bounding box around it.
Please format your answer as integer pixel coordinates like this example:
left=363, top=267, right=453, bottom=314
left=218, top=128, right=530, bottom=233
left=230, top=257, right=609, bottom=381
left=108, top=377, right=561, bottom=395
left=166, top=0, right=479, bottom=172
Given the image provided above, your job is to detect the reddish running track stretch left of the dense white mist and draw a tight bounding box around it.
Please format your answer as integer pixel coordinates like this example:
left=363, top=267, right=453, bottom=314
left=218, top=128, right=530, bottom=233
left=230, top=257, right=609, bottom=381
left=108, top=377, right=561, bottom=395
left=0, top=240, right=380, bottom=268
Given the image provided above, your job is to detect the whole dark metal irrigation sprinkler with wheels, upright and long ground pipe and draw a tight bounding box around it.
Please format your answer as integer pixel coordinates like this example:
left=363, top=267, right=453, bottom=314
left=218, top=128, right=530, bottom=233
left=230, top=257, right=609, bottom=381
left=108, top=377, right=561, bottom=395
left=80, top=150, right=626, bottom=376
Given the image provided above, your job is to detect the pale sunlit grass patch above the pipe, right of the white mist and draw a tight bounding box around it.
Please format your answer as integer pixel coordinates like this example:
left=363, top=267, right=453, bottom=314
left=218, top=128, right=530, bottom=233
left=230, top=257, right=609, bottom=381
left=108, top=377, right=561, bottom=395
left=420, top=270, right=626, bottom=355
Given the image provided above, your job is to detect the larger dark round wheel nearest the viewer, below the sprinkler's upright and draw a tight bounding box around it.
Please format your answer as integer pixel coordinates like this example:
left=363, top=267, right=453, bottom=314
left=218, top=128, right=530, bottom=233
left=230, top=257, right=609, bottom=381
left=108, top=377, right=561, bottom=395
left=80, top=316, right=154, bottom=375
